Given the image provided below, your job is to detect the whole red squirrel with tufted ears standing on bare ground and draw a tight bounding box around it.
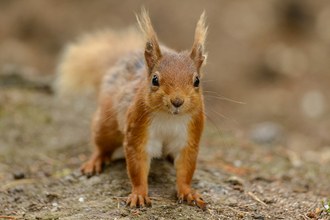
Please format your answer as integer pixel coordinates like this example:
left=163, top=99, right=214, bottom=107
left=56, top=9, right=207, bottom=209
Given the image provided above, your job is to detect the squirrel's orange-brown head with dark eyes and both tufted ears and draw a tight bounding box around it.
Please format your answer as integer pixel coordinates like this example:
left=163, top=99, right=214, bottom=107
left=138, top=9, right=207, bottom=115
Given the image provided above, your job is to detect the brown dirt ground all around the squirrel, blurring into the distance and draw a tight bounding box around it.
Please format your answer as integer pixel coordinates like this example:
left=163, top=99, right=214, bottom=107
left=0, top=0, right=330, bottom=220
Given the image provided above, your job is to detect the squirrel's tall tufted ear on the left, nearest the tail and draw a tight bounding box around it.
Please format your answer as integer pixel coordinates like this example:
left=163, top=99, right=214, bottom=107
left=136, top=8, right=162, bottom=72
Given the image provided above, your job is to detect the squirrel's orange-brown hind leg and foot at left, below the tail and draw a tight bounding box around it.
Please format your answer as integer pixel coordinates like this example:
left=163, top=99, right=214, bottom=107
left=80, top=99, right=124, bottom=177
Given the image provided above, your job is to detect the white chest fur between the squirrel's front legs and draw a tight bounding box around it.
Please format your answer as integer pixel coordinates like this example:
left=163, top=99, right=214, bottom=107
left=146, top=113, right=191, bottom=161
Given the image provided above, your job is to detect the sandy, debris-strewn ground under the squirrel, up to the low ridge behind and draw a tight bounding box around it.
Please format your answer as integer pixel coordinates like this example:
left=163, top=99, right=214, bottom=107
left=0, top=88, right=330, bottom=219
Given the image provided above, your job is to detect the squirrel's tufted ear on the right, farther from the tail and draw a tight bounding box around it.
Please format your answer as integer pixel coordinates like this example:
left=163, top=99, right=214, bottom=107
left=190, top=12, right=207, bottom=69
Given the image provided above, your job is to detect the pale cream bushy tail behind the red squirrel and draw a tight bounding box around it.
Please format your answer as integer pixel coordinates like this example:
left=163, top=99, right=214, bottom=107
left=55, top=27, right=143, bottom=95
